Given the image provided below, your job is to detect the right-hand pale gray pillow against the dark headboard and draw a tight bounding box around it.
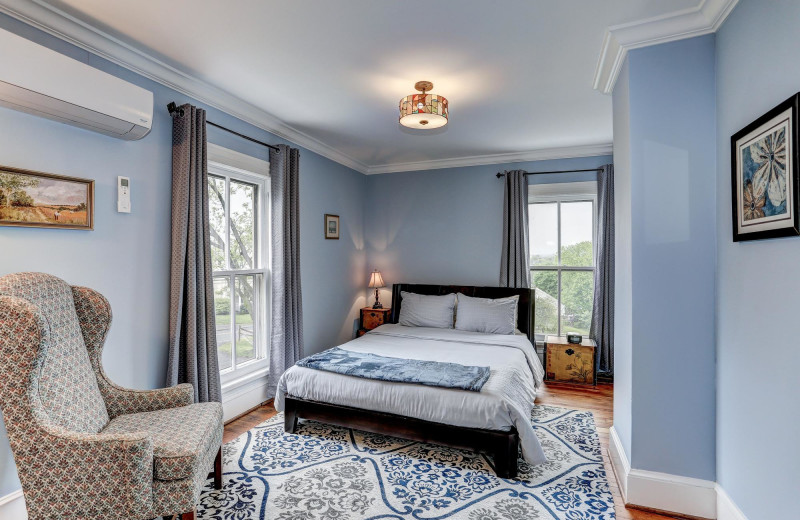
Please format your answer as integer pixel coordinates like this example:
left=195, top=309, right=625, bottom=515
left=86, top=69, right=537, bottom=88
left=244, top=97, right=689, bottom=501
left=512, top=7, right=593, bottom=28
left=456, top=293, right=519, bottom=334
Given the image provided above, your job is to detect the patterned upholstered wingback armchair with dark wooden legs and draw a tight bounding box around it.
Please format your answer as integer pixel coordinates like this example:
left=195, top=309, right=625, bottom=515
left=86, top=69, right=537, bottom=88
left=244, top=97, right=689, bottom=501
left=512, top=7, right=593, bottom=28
left=0, top=273, right=223, bottom=520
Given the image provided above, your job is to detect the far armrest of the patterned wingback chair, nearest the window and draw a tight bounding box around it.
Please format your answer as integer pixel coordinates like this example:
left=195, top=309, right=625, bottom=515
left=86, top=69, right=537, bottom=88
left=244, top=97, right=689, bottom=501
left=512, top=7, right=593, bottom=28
left=101, top=379, right=194, bottom=419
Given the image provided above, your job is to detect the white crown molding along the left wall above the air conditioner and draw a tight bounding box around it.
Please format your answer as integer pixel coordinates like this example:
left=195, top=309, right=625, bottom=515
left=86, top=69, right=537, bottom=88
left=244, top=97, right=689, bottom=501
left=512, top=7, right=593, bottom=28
left=0, top=0, right=367, bottom=173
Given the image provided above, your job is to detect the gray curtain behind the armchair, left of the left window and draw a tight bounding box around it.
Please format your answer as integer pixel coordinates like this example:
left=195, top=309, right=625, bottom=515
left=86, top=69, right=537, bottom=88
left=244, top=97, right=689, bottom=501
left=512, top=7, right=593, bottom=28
left=167, top=105, right=222, bottom=402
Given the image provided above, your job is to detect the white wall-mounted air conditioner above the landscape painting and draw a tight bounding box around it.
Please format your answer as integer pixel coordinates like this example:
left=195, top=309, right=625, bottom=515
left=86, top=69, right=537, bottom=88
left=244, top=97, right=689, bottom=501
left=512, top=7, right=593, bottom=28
left=0, top=29, right=153, bottom=139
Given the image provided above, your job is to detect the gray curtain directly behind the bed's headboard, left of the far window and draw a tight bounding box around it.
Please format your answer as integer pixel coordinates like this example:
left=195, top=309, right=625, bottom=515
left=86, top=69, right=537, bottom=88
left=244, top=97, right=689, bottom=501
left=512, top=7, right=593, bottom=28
left=500, top=170, right=531, bottom=287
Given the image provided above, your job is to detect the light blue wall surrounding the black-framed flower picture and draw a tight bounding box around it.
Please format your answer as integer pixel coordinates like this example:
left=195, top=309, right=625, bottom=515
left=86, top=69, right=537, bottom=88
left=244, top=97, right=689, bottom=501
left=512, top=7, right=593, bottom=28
left=717, top=0, right=800, bottom=520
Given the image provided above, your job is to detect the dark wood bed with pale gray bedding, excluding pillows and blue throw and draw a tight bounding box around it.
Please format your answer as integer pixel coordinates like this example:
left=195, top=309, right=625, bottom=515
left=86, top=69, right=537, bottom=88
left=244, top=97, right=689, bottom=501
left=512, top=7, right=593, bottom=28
left=275, top=284, right=546, bottom=478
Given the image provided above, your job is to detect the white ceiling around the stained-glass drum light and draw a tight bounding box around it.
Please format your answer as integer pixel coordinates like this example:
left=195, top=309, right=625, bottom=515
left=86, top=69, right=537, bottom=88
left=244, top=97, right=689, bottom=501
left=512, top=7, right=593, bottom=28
left=14, top=0, right=703, bottom=171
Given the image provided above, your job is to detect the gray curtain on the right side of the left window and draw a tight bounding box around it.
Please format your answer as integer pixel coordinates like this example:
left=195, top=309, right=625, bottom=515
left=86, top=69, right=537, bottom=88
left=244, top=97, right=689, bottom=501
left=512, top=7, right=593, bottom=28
left=267, top=145, right=303, bottom=396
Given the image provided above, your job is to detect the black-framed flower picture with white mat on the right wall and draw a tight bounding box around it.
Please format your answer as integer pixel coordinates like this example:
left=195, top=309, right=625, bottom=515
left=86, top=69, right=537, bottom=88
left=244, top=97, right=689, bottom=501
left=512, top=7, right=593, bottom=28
left=731, top=93, right=800, bottom=242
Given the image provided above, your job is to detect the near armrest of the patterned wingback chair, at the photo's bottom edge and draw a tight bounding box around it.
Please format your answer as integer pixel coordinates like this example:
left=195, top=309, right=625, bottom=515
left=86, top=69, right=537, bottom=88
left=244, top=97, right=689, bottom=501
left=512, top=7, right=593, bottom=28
left=23, top=420, right=153, bottom=518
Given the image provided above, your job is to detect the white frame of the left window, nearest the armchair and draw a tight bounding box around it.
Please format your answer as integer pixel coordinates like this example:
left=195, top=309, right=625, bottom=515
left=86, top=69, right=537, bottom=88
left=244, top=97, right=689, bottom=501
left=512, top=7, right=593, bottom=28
left=208, top=152, right=272, bottom=388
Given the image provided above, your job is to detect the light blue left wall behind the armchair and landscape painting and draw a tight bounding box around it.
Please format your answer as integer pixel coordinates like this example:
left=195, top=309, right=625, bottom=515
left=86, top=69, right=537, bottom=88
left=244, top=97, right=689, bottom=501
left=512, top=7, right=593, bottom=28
left=0, top=15, right=366, bottom=496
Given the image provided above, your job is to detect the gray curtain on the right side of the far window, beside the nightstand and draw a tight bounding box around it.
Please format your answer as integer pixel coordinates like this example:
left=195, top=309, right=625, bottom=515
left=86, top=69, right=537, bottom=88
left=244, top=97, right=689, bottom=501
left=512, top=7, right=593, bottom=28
left=589, top=164, right=614, bottom=376
